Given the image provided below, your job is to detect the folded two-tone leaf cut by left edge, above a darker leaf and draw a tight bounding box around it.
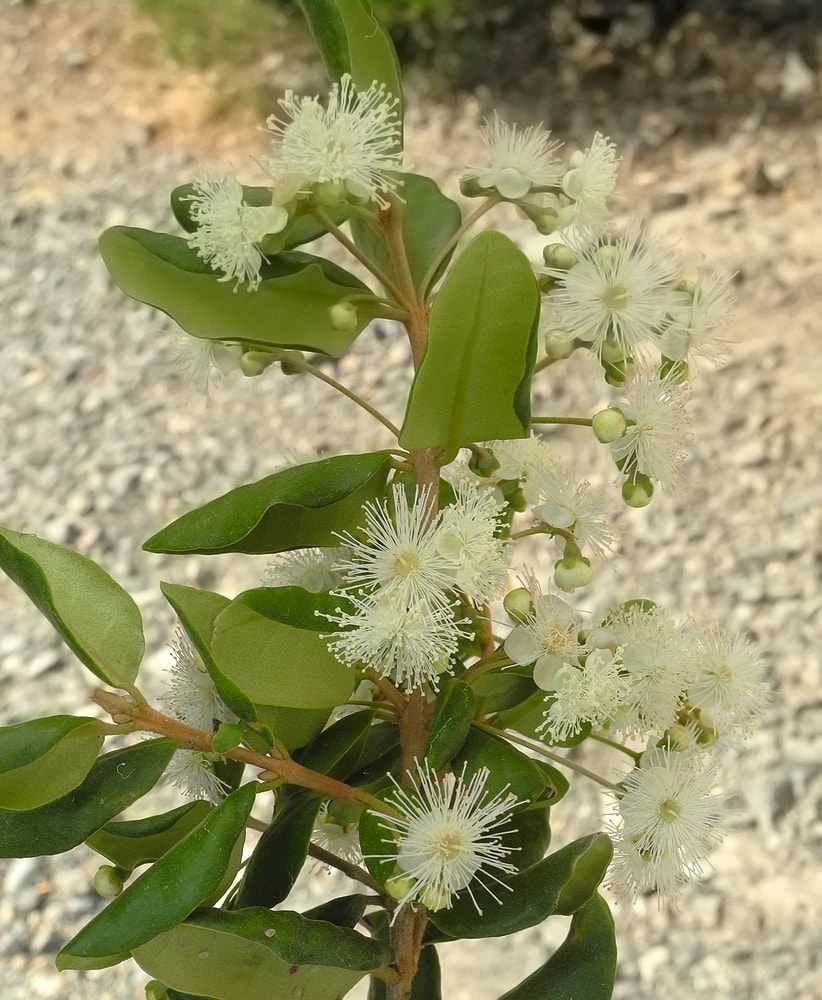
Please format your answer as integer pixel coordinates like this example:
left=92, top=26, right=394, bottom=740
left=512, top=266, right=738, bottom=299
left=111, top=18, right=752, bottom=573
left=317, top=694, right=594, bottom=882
left=0, top=715, right=104, bottom=810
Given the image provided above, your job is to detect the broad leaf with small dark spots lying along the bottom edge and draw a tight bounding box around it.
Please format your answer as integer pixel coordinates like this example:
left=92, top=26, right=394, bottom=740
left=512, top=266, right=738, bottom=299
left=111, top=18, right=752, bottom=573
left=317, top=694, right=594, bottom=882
left=133, top=908, right=392, bottom=1000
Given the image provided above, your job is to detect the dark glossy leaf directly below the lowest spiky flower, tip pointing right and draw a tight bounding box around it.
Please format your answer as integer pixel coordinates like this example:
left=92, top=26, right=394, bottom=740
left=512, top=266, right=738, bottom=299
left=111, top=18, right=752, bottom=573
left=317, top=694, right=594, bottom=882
left=429, top=833, right=613, bottom=938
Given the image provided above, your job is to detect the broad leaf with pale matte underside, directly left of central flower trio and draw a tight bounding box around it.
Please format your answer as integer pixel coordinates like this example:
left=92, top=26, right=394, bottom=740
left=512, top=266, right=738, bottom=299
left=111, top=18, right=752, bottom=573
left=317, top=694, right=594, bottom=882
left=211, top=604, right=355, bottom=712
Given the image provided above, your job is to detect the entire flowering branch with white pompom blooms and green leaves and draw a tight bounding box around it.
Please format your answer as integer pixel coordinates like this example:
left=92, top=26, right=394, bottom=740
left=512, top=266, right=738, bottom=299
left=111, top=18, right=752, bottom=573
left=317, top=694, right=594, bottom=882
left=0, top=0, right=765, bottom=1000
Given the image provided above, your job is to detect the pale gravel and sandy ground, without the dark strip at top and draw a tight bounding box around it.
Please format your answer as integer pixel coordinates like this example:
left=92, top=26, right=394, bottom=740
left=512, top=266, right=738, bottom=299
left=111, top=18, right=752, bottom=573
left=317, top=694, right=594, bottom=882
left=0, top=0, right=822, bottom=1000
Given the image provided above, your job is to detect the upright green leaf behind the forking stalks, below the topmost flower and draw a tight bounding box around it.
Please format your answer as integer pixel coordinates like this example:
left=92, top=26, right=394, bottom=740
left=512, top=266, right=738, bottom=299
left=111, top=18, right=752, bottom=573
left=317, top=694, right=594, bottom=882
left=350, top=174, right=462, bottom=295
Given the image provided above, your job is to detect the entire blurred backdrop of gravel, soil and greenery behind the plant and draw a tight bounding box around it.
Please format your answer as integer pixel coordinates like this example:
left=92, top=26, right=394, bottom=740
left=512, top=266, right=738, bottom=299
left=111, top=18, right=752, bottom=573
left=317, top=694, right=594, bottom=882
left=0, top=0, right=822, bottom=1000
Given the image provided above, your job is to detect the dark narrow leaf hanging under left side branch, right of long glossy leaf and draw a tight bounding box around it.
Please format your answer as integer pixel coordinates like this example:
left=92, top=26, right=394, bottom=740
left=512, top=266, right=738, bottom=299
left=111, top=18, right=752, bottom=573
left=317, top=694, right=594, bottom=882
left=234, top=794, right=321, bottom=909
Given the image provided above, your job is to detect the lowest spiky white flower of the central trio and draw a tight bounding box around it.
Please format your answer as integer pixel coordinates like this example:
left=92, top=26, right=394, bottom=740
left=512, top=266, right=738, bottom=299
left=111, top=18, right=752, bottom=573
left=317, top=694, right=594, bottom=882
left=323, top=590, right=469, bottom=691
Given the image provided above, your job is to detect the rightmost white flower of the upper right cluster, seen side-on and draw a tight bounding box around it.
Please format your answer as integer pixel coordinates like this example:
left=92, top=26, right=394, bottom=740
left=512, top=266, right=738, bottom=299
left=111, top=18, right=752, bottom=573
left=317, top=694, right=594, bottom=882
left=660, top=267, right=736, bottom=364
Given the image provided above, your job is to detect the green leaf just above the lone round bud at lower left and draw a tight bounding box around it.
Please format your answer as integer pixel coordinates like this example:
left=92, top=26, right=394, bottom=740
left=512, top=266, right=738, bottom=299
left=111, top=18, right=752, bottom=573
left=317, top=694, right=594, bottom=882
left=86, top=801, right=214, bottom=872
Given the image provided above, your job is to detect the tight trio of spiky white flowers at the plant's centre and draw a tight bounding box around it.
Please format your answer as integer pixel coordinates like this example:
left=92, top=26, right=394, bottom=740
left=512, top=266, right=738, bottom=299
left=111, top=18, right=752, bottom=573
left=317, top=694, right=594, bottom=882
left=326, top=481, right=508, bottom=690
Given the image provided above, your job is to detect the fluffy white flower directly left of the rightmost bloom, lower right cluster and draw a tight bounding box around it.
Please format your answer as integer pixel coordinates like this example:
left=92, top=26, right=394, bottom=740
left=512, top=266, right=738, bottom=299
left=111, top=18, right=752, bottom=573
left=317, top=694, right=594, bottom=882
left=607, top=605, right=690, bottom=733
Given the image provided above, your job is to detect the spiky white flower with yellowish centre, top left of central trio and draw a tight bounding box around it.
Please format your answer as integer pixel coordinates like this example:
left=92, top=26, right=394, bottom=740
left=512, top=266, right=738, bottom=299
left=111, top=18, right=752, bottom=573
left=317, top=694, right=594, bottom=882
left=335, top=485, right=454, bottom=604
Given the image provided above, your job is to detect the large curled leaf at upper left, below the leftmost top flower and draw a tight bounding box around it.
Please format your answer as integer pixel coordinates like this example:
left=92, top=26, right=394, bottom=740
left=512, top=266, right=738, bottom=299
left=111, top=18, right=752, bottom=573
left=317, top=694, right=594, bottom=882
left=100, top=226, right=379, bottom=358
